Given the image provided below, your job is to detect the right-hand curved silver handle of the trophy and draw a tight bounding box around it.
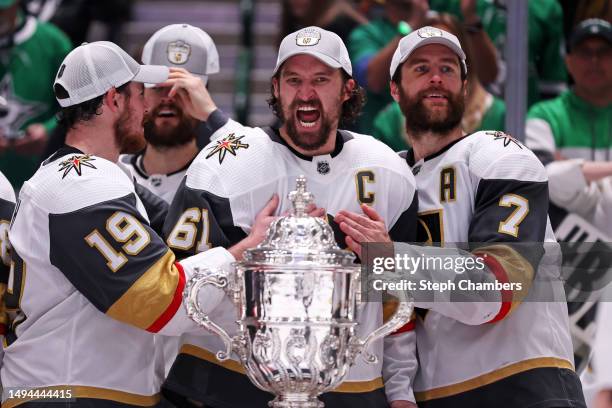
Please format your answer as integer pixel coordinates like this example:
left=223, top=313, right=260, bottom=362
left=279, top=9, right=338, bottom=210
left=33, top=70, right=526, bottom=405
left=349, top=286, right=414, bottom=364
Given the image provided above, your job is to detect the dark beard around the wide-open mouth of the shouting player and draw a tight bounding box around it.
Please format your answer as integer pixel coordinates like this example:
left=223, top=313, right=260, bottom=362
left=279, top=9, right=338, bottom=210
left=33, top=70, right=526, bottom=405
left=279, top=94, right=342, bottom=151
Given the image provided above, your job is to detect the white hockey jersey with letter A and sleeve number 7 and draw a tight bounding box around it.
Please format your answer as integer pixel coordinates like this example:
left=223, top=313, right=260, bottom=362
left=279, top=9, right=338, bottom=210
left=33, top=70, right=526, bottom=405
left=400, top=131, right=583, bottom=408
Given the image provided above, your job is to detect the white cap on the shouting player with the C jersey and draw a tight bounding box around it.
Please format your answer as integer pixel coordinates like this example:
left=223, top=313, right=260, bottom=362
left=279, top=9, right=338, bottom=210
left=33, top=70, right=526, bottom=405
left=272, top=26, right=353, bottom=76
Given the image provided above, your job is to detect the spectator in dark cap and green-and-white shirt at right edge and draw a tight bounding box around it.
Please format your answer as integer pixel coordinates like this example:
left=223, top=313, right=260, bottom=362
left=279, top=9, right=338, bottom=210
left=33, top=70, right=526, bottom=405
left=526, top=19, right=612, bottom=235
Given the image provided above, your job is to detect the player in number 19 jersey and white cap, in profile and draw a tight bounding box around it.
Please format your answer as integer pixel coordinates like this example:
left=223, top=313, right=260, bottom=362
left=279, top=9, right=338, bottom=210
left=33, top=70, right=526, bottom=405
left=1, top=41, right=278, bottom=407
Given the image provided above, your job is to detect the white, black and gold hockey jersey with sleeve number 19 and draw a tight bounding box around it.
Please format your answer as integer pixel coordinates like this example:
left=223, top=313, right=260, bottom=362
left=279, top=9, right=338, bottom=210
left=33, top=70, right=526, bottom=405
left=1, top=147, right=234, bottom=407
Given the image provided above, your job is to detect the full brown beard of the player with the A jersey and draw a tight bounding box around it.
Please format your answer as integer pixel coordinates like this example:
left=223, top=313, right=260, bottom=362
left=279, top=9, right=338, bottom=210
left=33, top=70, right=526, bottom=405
left=399, top=86, right=465, bottom=137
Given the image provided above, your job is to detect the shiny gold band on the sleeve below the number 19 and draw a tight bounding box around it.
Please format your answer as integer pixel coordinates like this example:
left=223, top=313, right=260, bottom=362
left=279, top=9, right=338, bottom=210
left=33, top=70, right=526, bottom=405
left=106, top=250, right=179, bottom=329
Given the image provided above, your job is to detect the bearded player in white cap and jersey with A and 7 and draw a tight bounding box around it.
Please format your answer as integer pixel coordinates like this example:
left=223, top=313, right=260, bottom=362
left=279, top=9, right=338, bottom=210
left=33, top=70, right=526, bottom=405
left=336, top=27, right=584, bottom=408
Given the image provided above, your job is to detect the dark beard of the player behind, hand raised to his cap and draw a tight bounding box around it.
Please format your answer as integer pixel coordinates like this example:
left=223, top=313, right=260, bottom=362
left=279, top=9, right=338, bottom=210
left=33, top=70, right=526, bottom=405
left=144, top=105, right=198, bottom=148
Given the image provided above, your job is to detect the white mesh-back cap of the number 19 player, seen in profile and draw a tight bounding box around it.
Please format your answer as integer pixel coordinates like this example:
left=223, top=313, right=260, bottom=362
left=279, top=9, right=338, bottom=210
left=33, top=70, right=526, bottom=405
left=53, top=41, right=169, bottom=107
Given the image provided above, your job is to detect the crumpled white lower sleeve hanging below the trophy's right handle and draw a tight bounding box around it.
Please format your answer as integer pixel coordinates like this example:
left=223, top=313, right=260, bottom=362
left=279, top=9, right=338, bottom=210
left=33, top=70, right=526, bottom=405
left=383, top=329, right=418, bottom=403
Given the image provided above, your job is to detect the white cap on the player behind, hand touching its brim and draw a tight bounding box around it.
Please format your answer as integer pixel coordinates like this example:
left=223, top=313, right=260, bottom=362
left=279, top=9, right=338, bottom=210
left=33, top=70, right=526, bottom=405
left=142, top=24, right=219, bottom=84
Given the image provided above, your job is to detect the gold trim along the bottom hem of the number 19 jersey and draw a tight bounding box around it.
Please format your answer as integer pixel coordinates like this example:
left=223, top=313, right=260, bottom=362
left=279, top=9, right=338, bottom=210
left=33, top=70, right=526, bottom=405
left=2, top=385, right=161, bottom=408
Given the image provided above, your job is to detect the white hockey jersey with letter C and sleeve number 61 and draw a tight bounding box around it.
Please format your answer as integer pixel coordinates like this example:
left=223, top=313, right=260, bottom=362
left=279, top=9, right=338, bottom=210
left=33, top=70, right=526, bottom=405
left=164, top=113, right=417, bottom=408
